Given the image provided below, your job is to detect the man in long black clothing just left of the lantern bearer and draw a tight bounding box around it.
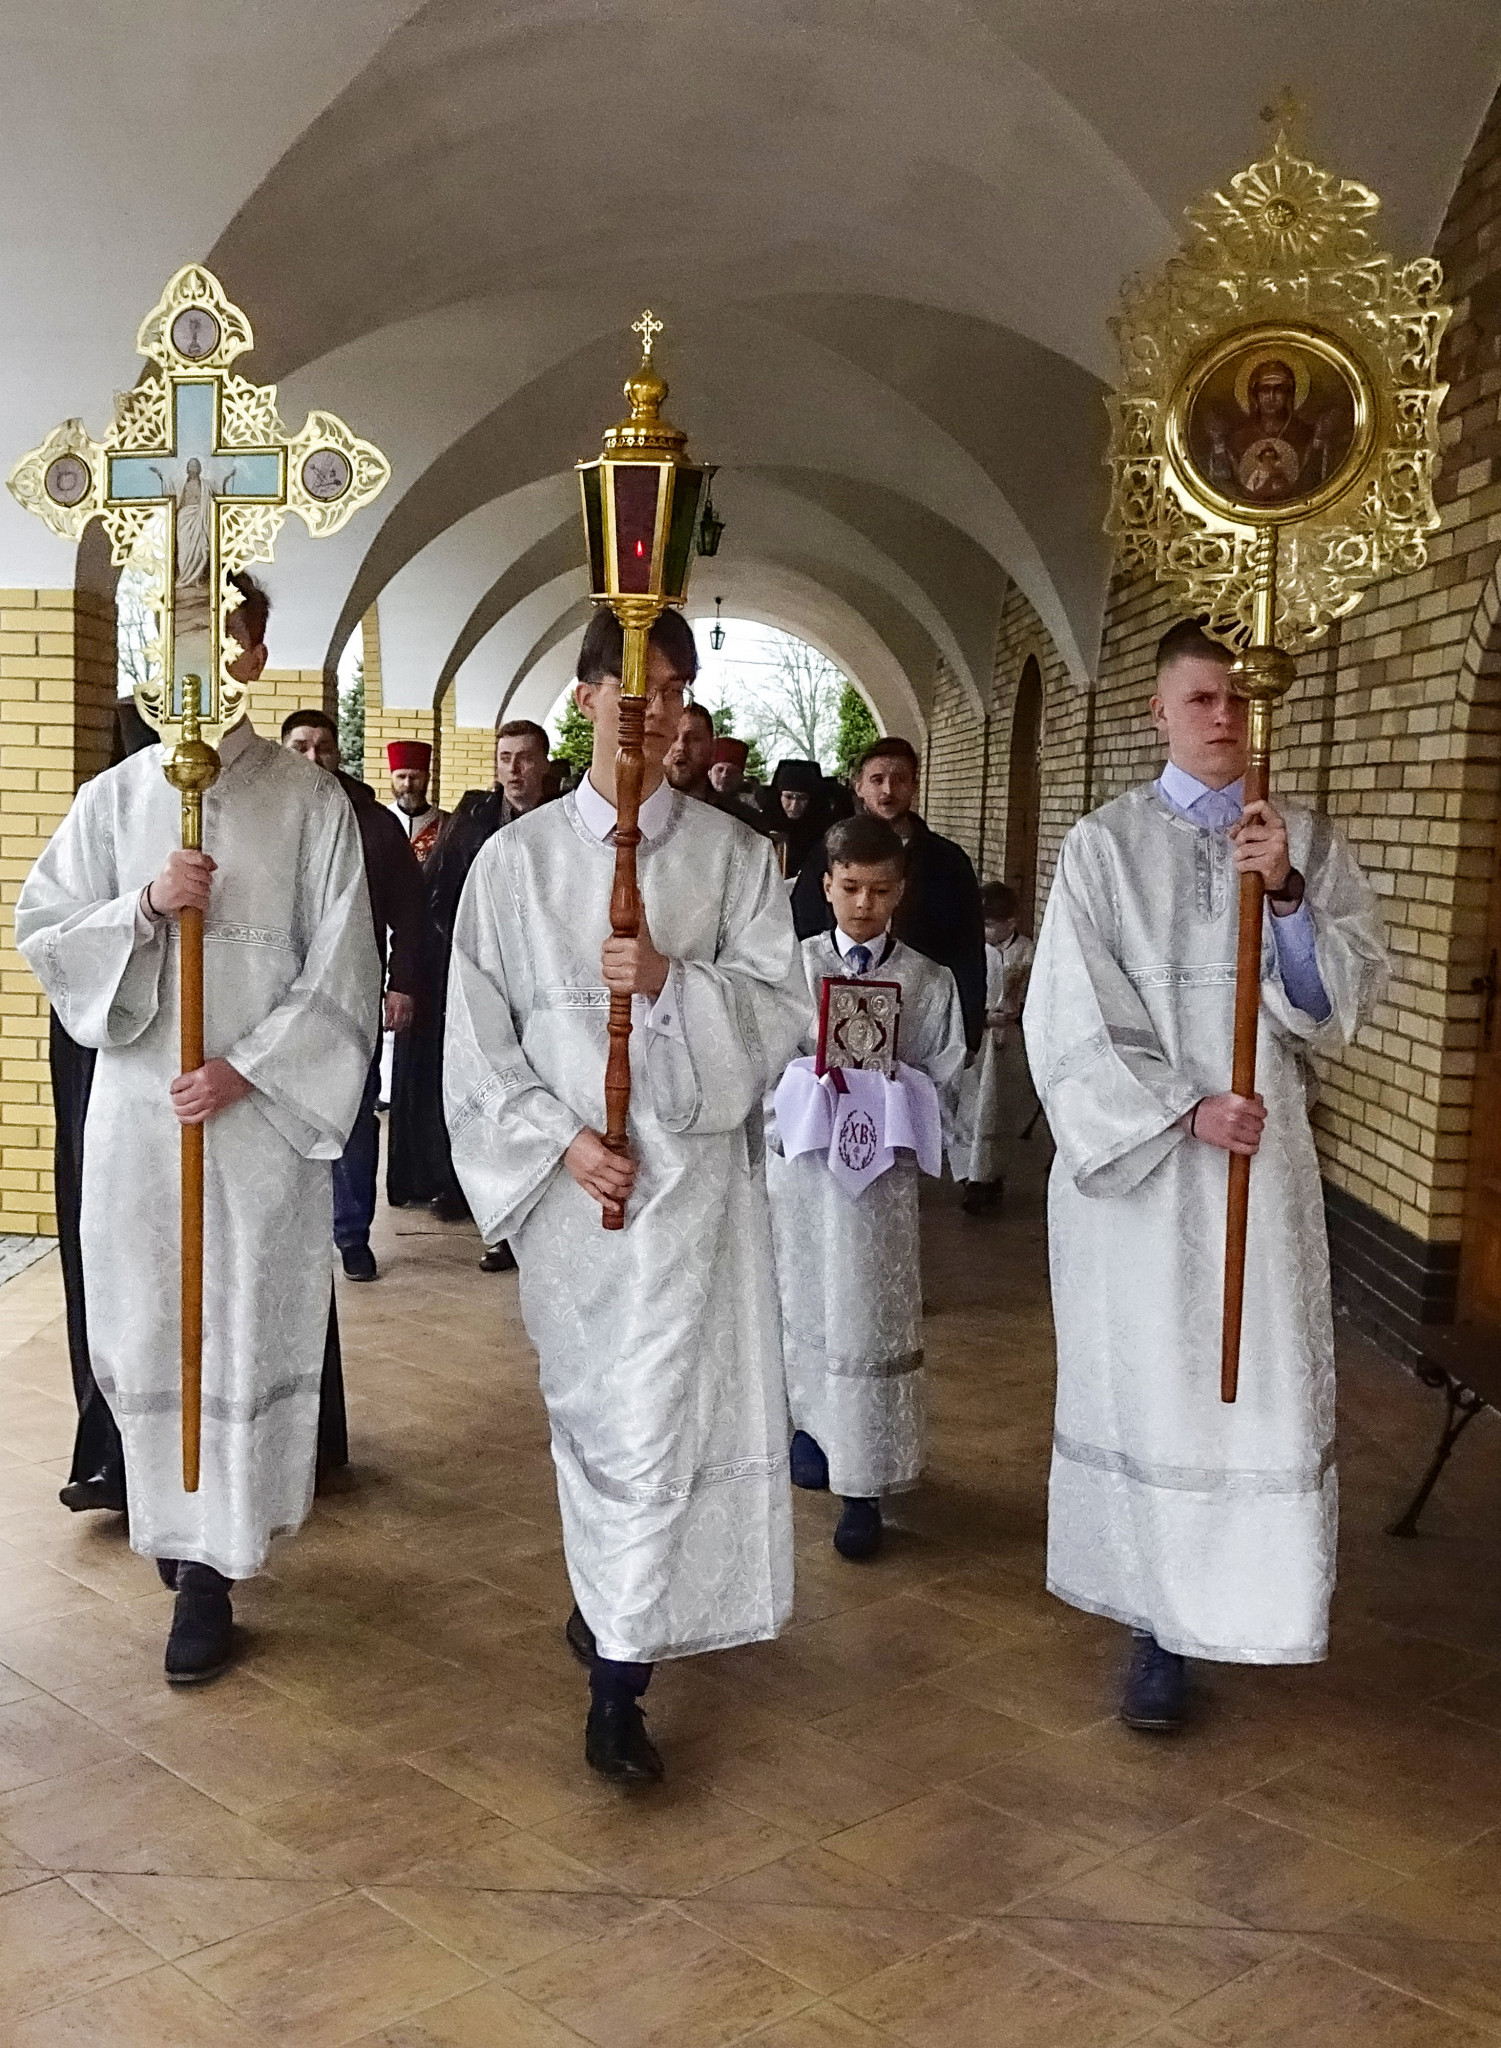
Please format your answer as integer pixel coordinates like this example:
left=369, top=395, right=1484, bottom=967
left=385, top=719, right=549, bottom=1272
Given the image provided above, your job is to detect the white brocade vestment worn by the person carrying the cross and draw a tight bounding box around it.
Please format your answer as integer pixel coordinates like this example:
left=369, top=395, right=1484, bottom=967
left=16, top=723, right=381, bottom=1579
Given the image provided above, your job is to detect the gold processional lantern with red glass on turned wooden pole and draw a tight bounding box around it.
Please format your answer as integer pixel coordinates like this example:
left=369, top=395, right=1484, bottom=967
left=577, top=307, right=706, bottom=1231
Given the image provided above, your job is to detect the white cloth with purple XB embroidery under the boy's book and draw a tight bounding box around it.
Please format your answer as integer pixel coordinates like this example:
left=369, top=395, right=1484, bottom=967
left=772, top=1059, right=944, bottom=1196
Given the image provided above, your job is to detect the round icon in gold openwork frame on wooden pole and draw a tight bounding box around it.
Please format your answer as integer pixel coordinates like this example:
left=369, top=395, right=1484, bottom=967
left=1106, top=119, right=1450, bottom=1401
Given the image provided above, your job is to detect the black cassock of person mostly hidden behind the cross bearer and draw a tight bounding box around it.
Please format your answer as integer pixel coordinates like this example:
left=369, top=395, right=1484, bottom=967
left=47, top=698, right=350, bottom=1507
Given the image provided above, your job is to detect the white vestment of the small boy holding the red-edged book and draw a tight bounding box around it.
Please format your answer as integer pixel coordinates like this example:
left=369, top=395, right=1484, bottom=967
left=766, top=932, right=964, bottom=1499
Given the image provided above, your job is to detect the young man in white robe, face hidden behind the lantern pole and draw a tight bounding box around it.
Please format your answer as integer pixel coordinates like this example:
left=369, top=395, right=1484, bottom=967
left=444, top=610, right=807, bottom=1780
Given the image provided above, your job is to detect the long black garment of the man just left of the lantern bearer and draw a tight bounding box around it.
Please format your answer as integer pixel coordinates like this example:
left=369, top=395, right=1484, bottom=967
left=385, top=788, right=522, bottom=1208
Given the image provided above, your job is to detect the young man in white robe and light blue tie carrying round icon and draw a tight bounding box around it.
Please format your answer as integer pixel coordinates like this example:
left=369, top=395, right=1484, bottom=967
left=1024, top=621, right=1386, bottom=1729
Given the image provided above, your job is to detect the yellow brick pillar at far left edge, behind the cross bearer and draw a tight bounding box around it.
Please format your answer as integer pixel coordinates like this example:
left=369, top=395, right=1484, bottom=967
left=0, top=590, right=115, bottom=1235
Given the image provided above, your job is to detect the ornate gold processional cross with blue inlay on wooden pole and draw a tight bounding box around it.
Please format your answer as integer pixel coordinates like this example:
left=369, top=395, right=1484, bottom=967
left=8, top=264, right=391, bottom=1493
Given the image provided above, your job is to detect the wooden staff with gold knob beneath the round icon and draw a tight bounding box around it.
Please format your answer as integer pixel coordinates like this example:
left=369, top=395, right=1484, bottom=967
left=1220, top=526, right=1294, bottom=1401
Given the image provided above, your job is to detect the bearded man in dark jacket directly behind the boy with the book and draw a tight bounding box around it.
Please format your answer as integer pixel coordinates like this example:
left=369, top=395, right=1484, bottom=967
left=792, top=739, right=985, bottom=1053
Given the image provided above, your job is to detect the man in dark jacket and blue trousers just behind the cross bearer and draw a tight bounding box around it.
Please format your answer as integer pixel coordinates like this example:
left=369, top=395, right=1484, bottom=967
left=281, top=711, right=424, bottom=1280
